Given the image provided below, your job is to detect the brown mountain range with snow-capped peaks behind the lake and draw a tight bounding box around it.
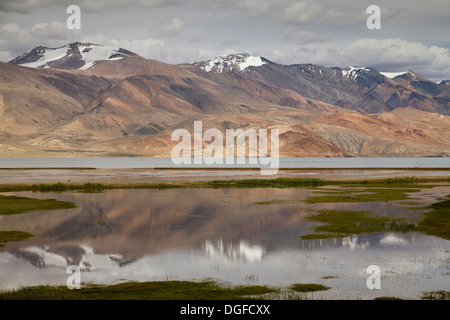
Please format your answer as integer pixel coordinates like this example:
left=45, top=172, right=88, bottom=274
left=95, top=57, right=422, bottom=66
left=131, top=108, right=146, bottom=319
left=0, top=42, right=450, bottom=157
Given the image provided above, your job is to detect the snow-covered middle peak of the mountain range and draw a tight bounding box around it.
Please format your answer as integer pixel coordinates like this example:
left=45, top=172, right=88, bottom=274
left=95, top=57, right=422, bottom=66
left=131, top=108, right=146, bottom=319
left=195, top=53, right=267, bottom=73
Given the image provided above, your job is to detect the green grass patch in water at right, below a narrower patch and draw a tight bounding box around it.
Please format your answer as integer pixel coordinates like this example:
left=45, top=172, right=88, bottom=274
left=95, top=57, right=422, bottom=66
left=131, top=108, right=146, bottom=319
left=301, top=210, right=417, bottom=240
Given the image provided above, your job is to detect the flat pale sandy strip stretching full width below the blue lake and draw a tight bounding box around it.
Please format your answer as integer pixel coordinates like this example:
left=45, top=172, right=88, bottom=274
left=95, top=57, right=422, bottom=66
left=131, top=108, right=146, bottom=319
left=0, top=169, right=450, bottom=184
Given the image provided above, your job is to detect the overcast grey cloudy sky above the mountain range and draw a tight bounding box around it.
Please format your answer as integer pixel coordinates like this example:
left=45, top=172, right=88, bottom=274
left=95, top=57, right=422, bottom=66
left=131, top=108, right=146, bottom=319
left=0, top=0, right=450, bottom=81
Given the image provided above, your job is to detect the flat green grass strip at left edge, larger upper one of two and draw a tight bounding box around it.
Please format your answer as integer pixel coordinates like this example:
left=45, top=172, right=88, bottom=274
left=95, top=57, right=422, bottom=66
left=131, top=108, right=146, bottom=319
left=0, top=195, right=76, bottom=215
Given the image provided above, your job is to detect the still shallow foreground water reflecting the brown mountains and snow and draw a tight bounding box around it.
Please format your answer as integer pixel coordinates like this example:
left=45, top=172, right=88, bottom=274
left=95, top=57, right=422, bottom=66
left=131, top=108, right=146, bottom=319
left=0, top=187, right=450, bottom=299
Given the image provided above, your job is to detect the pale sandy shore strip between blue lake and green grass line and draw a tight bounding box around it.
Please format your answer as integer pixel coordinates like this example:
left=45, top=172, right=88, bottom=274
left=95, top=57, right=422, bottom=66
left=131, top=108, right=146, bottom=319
left=0, top=167, right=450, bottom=187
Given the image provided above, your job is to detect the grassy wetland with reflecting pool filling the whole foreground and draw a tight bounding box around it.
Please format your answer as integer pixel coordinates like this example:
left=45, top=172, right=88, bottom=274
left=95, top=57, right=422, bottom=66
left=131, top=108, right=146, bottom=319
left=0, top=177, right=450, bottom=299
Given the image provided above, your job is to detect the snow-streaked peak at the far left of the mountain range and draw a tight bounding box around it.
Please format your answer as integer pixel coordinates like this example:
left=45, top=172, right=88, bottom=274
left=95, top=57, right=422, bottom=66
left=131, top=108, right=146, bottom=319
left=9, top=42, right=136, bottom=70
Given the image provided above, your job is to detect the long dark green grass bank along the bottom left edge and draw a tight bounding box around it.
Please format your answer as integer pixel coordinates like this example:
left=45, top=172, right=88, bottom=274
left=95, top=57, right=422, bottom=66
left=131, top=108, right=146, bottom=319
left=0, top=281, right=278, bottom=300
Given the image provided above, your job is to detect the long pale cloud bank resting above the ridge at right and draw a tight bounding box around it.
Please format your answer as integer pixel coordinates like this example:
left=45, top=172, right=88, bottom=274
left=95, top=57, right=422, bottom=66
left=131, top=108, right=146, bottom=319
left=263, top=37, right=450, bottom=81
